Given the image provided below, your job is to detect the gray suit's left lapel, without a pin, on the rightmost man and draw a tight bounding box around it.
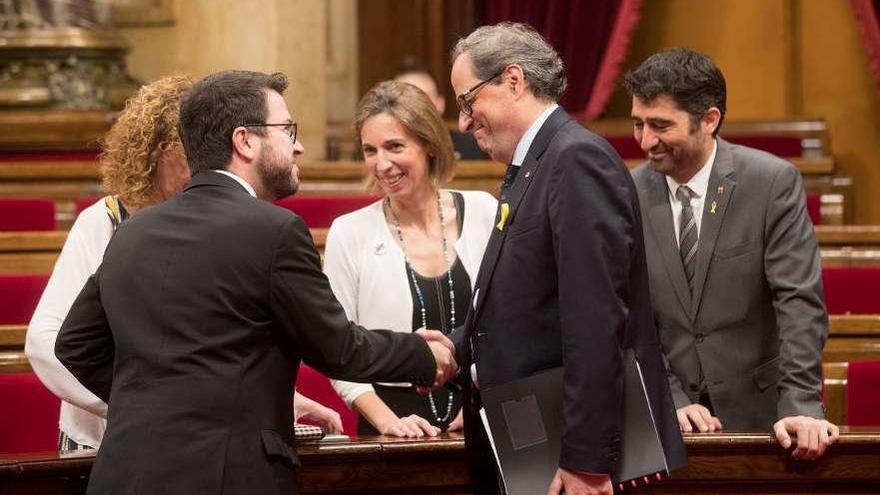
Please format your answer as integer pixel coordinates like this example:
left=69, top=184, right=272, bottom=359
left=647, top=171, right=691, bottom=315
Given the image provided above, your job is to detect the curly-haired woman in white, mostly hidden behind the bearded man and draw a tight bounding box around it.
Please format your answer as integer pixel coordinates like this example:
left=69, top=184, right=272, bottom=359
left=25, top=75, right=192, bottom=451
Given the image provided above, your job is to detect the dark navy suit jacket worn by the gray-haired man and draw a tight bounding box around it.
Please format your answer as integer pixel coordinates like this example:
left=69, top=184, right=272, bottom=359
left=454, top=109, right=685, bottom=491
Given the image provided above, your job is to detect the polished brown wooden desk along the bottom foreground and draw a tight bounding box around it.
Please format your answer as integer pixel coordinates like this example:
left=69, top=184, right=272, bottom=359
left=0, top=428, right=880, bottom=494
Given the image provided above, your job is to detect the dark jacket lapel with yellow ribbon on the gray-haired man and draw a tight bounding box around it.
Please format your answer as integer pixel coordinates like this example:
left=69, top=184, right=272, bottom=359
left=473, top=107, right=570, bottom=322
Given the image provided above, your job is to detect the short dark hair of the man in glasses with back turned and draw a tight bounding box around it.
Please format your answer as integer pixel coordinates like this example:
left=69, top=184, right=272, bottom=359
left=179, top=70, right=287, bottom=174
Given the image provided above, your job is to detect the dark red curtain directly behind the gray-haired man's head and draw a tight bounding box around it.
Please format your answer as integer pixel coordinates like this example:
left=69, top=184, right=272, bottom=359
left=486, top=0, right=644, bottom=120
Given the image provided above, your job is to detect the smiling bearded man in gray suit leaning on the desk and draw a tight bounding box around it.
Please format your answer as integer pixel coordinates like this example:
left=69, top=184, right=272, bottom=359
left=624, top=49, right=838, bottom=459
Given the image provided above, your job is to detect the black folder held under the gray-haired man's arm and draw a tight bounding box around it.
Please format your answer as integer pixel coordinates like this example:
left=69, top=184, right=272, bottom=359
left=480, top=349, right=668, bottom=495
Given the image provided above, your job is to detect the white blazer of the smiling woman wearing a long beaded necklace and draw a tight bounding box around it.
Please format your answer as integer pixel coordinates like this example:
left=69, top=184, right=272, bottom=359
left=324, top=191, right=498, bottom=406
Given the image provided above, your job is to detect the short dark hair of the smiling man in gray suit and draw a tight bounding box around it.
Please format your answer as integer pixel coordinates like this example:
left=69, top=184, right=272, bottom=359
left=623, top=48, right=727, bottom=135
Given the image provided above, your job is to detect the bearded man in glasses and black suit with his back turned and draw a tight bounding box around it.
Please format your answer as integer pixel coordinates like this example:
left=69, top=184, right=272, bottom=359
left=56, top=71, right=455, bottom=494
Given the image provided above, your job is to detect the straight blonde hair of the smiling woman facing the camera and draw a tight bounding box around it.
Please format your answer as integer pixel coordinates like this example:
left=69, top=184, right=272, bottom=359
left=354, top=81, right=455, bottom=190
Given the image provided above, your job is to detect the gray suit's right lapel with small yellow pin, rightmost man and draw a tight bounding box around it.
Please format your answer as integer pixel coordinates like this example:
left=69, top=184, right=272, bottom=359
left=690, top=138, right=736, bottom=319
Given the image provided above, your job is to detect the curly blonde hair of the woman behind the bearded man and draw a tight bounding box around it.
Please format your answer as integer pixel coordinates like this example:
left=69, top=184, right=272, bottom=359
left=98, top=75, right=193, bottom=209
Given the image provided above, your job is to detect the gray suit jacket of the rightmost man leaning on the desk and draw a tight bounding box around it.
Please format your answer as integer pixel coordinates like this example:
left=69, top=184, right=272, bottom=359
left=633, top=139, right=828, bottom=429
